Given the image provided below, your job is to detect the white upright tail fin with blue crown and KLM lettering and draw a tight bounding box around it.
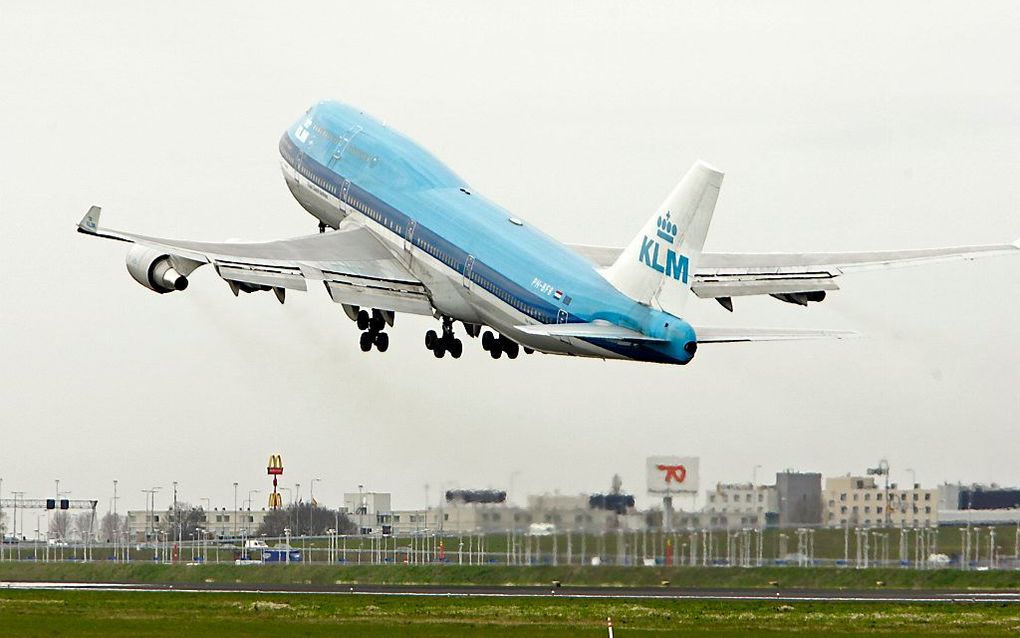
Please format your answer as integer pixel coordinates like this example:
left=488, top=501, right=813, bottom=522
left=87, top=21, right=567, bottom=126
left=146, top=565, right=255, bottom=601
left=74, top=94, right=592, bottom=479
left=603, top=161, right=722, bottom=314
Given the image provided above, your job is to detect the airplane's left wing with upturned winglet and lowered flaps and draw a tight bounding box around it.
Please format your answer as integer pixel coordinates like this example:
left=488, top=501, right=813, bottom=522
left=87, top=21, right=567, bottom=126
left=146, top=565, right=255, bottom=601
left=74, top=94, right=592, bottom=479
left=78, top=206, right=432, bottom=315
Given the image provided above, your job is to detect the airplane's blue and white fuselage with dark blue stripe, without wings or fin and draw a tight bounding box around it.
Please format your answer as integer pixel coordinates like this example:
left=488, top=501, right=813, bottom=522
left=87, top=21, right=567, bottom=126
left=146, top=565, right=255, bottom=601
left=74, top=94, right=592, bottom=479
left=279, top=102, right=696, bottom=363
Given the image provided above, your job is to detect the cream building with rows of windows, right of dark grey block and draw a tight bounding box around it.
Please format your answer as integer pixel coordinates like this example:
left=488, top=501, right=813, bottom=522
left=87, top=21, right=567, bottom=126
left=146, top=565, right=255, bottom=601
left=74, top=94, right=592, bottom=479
left=822, top=475, right=938, bottom=528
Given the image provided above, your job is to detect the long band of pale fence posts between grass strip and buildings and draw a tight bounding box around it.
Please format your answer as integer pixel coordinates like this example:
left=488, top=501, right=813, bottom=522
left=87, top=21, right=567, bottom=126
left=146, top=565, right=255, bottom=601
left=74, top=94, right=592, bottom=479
left=0, top=527, right=1020, bottom=570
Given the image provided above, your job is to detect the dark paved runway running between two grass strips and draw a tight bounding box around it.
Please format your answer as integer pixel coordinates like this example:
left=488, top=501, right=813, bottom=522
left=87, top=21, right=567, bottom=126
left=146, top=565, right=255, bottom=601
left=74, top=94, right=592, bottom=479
left=0, top=581, right=1020, bottom=604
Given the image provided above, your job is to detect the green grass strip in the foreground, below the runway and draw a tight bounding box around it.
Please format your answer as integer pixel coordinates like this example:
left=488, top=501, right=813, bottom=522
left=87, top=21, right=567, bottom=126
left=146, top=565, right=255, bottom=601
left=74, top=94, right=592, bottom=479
left=0, top=590, right=1020, bottom=638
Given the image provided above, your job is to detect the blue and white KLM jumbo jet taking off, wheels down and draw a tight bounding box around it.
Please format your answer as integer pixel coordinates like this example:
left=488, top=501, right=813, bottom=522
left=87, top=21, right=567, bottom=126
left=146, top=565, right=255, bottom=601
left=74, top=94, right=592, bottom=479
left=78, top=101, right=1020, bottom=364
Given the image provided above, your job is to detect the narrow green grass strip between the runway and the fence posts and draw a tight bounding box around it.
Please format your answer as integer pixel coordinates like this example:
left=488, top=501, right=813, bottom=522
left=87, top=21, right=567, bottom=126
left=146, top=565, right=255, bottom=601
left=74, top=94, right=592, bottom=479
left=0, top=562, right=1020, bottom=589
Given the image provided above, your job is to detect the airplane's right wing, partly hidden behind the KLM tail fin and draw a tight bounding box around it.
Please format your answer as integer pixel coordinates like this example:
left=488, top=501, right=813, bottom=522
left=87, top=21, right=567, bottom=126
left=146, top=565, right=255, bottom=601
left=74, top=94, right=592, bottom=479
left=571, top=240, right=1020, bottom=309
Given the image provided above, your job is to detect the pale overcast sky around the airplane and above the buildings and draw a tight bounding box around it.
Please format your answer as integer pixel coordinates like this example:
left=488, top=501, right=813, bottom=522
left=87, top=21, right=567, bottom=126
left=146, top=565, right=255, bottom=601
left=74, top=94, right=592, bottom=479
left=0, top=0, right=1020, bottom=508
